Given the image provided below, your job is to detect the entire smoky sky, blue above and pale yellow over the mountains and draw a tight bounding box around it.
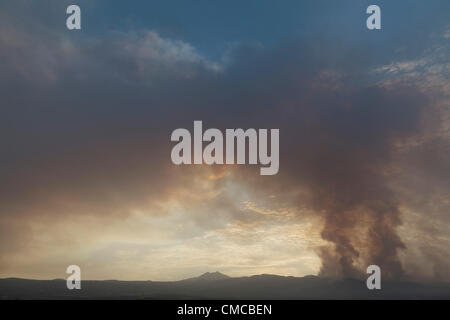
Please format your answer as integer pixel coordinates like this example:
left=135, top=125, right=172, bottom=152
left=0, top=0, right=450, bottom=281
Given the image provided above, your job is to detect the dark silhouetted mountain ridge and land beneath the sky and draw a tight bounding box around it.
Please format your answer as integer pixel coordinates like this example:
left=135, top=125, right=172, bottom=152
left=0, top=271, right=450, bottom=300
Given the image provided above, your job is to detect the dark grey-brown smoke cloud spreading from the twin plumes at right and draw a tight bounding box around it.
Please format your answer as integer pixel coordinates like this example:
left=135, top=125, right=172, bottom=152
left=0, top=1, right=450, bottom=278
